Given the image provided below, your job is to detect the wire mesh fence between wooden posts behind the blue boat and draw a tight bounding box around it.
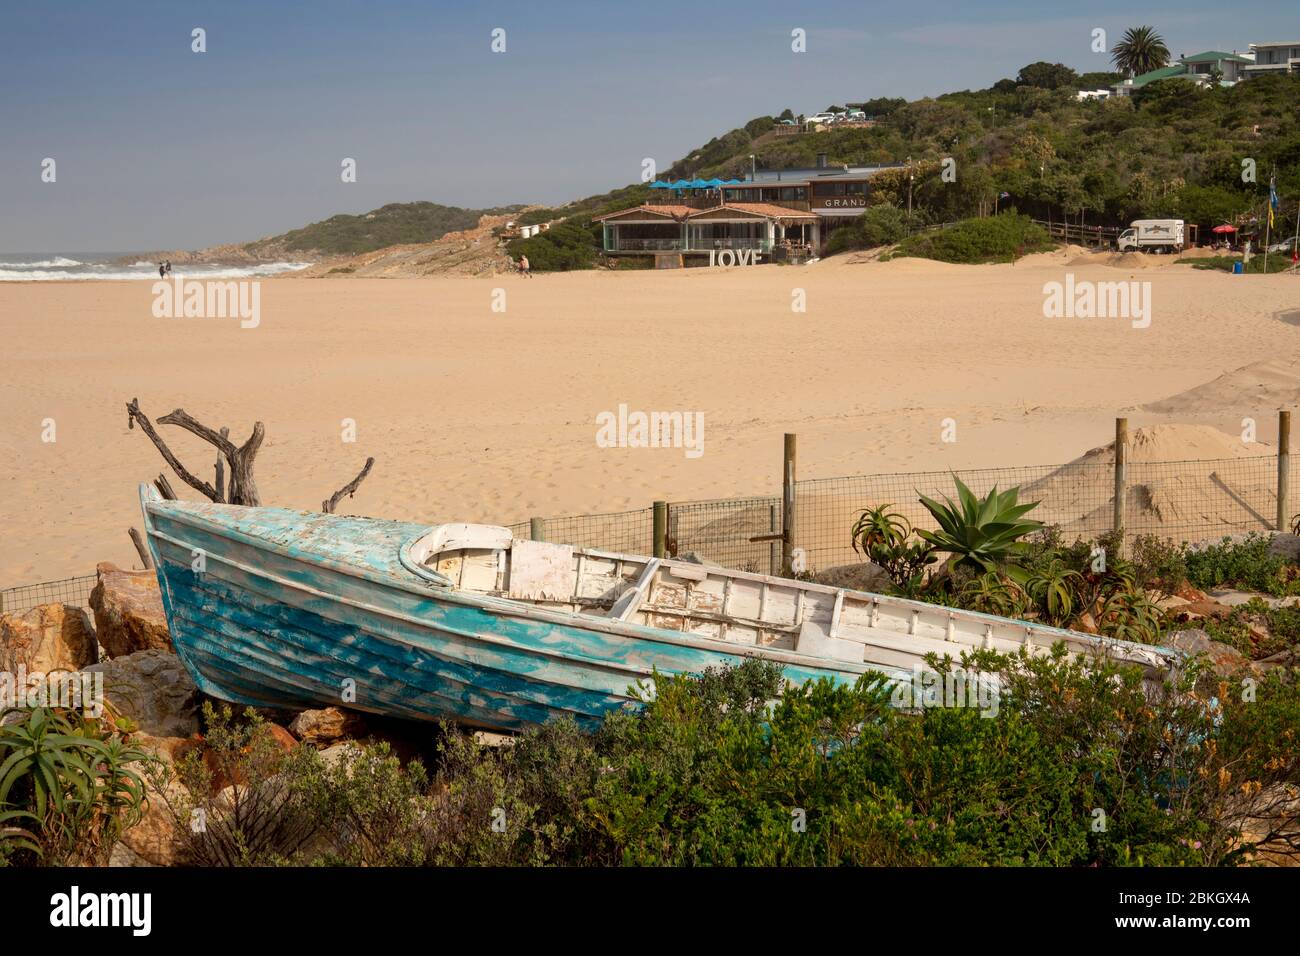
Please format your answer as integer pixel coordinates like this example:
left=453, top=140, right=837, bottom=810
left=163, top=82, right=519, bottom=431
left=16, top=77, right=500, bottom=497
left=0, top=449, right=1300, bottom=614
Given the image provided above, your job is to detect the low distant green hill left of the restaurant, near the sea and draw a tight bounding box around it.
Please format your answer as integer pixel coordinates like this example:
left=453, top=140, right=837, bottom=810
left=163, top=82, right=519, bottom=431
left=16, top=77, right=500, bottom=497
left=243, top=202, right=524, bottom=258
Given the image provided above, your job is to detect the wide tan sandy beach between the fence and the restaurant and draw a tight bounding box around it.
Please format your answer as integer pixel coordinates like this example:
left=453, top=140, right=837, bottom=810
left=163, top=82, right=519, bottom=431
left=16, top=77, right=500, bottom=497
left=0, top=251, right=1300, bottom=587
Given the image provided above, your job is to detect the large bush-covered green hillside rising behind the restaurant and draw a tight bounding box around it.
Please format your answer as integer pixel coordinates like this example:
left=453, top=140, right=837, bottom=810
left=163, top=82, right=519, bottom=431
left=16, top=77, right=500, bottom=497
left=511, top=54, right=1300, bottom=269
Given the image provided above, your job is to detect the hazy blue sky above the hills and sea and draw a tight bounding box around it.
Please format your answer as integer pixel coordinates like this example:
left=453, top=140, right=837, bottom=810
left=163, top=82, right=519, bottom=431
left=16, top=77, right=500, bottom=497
left=0, top=0, right=1300, bottom=252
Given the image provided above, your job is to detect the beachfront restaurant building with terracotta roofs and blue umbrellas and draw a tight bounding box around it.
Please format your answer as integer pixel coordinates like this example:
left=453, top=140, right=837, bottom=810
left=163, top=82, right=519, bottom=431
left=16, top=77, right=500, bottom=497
left=594, top=156, right=887, bottom=265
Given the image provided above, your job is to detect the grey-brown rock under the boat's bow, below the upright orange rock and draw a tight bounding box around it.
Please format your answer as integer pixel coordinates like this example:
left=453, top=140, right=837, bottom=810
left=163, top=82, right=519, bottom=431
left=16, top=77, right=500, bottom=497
left=86, top=648, right=199, bottom=737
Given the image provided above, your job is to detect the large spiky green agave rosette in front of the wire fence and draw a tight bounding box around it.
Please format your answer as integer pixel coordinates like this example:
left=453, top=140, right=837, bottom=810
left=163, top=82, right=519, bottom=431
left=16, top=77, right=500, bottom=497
left=917, top=475, right=1043, bottom=574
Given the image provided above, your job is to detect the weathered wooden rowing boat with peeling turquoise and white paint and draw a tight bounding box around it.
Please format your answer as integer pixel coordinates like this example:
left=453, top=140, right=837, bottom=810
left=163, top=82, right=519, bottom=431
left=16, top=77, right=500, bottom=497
left=140, top=485, right=1177, bottom=730
